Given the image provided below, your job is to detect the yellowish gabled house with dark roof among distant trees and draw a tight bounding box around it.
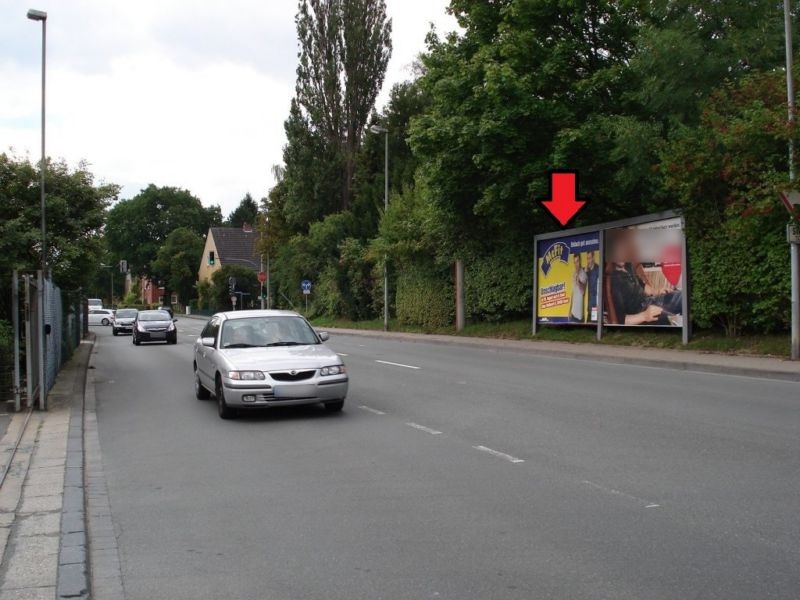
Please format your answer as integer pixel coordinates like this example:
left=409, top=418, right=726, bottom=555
left=197, top=223, right=261, bottom=281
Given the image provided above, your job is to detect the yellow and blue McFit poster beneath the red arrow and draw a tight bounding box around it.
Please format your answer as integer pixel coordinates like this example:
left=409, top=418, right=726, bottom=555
left=536, top=231, right=600, bottom=324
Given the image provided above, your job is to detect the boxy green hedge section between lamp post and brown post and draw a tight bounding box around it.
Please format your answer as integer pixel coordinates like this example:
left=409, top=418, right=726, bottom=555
left=395, top=267, right=455, bottom=329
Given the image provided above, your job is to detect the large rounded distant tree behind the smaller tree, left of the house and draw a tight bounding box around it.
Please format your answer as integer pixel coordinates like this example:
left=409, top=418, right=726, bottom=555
left=106, top=184, right=222, bottom=274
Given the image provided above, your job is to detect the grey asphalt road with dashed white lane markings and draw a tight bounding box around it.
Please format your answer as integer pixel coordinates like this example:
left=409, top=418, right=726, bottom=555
left=93, top=319, right=800, bottom=600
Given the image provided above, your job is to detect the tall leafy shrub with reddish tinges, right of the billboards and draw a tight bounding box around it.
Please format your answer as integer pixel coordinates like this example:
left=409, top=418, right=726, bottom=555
left=662, top=72, right=798, bottom=335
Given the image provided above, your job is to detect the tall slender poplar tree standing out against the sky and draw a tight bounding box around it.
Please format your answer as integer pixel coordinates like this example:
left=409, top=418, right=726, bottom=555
left=295, top=0, right=392, bottom=209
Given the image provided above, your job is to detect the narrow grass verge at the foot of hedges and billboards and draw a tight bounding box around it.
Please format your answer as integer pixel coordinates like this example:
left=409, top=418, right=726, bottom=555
left=312, top=317, right=790, bottom=357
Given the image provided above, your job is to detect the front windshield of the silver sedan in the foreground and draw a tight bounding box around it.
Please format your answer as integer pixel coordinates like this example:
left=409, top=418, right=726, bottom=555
left=221, top=316, right=319, bottom=348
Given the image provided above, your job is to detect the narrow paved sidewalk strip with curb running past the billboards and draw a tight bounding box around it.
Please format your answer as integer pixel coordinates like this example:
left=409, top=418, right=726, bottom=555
left=318, top=328, right=800, bottom=382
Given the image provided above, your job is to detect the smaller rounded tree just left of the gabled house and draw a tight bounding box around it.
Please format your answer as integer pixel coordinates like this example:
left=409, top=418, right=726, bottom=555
left=152, top=227, right=205, bottom=304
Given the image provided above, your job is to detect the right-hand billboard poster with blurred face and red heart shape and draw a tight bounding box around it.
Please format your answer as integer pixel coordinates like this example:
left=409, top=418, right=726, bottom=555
left=603, top=217, right=683, bottom=327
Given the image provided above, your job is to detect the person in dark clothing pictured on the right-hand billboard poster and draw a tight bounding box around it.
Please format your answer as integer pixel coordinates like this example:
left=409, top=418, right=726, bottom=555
left=606, top=229, right=683, bottom=326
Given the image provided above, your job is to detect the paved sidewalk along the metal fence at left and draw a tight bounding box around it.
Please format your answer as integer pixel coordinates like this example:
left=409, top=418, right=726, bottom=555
left=0, top=340, right=93, bottom=600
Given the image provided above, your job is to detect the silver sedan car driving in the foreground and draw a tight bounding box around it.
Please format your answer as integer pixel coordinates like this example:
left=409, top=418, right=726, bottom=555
left=194, top=310, right=348, bottom=419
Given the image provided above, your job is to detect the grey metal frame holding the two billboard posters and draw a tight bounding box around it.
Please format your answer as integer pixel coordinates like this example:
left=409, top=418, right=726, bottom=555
left=531, top=210, right=691, bottom=345
